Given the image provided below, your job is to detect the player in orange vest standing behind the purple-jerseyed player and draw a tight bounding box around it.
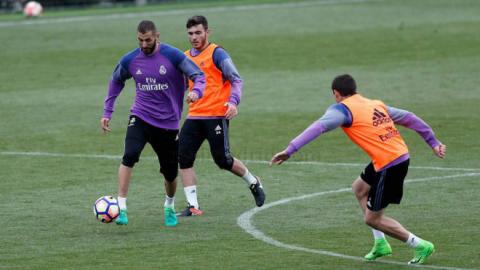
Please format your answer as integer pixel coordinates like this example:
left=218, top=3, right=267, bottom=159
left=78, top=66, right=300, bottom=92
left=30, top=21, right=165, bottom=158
left=179, top=16, right=265, bottom=216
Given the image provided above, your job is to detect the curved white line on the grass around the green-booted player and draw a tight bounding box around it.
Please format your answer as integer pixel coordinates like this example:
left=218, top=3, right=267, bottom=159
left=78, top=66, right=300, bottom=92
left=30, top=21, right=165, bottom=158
left=237, top=173, right=480, bottom=270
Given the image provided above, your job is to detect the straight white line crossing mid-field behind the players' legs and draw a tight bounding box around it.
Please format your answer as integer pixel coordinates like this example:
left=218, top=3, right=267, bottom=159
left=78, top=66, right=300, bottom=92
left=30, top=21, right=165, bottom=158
left=0, top=151, right=480, bottom=172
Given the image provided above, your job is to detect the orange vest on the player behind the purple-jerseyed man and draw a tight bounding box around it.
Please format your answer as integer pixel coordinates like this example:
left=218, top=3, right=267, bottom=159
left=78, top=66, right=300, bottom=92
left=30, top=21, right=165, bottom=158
left=185, top=43, right=231, bottom=117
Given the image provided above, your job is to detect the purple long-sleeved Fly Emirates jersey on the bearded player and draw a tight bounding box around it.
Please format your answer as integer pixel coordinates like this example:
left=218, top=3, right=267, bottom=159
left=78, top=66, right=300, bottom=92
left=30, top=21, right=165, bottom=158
left=103, top=43, right=205, bottom=129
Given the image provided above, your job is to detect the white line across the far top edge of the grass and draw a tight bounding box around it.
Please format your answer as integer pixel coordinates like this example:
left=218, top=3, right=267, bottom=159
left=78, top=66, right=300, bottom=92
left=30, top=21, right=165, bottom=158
left=0, top=0, right=367, bottom=27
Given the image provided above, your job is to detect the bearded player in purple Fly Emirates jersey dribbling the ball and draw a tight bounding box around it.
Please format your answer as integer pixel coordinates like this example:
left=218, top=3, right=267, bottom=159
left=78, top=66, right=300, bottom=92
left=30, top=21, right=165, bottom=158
left=100, top=21, right=205, bottom=226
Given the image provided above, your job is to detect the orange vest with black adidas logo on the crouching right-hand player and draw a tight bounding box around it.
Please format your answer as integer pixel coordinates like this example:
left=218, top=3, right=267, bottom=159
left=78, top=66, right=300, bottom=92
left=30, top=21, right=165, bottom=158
left=341, top=94, right=408, bottom=171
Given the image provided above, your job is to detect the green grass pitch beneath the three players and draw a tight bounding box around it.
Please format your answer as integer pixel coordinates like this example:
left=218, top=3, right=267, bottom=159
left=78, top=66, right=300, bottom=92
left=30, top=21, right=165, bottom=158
left=0, top=0, right=480, bottom=269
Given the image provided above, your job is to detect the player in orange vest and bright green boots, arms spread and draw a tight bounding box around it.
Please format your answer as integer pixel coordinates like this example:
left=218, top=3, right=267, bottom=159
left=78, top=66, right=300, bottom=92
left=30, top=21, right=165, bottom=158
left=270, top=74, right=446, bottom=264
